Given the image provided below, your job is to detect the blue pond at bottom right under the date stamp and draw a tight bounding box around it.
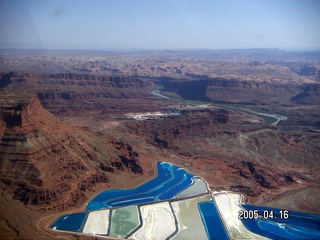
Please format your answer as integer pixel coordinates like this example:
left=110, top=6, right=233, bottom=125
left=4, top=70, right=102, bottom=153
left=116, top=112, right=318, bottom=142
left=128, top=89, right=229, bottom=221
left=242, top=204, right=320, bottom=239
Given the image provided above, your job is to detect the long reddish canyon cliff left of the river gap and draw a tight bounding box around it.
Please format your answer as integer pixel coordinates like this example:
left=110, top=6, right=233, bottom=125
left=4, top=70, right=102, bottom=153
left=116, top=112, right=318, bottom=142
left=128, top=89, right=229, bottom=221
left=0, top=72, right=151, bottom=100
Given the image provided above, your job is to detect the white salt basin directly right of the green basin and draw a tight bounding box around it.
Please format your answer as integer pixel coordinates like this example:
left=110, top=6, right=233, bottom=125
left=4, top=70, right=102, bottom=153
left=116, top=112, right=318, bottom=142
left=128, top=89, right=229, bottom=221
left=130, top=202, right=176, bottom=240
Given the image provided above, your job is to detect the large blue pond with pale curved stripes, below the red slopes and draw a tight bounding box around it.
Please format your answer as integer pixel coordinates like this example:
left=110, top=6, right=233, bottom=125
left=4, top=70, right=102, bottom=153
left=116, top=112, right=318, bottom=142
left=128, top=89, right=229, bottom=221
left=86, top=162, right=194, bottom=210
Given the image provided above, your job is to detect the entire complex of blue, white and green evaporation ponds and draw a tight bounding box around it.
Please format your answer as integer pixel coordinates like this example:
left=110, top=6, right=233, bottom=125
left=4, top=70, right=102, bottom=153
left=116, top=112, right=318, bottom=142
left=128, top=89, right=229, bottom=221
left=51, top=162, right=320, bottom=240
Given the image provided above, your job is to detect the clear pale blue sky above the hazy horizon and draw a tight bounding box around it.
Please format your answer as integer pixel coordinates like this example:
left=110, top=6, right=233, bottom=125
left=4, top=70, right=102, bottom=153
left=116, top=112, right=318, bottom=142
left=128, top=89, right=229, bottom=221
left=0, top=0, right=320, bottom=50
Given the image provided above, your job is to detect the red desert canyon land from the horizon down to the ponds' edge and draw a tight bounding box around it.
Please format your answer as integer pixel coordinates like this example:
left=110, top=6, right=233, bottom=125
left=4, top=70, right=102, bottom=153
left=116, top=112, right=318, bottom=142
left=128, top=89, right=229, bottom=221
left=0, top=49, right=320, bottom=239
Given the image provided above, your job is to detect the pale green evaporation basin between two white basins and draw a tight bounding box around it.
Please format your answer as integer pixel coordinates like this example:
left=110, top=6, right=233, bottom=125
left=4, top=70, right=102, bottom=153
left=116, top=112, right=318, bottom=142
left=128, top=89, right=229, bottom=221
left=109, top=205, right=140, bottom=238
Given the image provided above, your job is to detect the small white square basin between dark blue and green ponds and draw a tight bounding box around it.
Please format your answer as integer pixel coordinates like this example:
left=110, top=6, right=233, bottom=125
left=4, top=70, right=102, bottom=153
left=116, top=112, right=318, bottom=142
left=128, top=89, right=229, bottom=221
left=82, top=210, right=110, bottom=234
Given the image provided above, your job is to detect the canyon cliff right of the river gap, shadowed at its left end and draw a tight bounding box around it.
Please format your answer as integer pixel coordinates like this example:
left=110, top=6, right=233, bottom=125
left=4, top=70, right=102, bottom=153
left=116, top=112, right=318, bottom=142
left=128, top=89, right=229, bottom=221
left=163, top=78, right=320, bottom=104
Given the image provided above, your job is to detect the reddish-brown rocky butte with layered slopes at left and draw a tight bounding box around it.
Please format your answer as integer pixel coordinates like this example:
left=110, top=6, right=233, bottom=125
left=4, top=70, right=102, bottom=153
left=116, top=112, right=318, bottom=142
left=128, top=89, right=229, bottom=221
left=0, top=92, right=143, bottom=210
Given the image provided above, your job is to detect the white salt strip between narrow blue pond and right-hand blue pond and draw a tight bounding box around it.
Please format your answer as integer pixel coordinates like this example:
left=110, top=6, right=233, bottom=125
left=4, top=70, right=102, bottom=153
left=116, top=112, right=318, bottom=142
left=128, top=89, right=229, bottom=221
left=213, top=192, right=268, bottom=239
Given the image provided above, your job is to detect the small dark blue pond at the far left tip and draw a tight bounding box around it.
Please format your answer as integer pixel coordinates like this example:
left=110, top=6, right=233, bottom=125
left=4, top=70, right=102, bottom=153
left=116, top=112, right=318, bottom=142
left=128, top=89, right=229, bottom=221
left=50, top=212, right=86, bottom=232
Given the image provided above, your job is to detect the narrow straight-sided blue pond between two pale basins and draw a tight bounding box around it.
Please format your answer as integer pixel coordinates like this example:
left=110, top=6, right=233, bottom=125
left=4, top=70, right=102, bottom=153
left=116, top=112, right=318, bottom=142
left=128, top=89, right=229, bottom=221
left=198, top=201, right=229, bottom=240
